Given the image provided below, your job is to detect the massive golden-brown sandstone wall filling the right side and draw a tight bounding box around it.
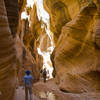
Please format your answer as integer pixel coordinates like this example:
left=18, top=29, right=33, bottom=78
left=44, top=0, right=100, bottom=92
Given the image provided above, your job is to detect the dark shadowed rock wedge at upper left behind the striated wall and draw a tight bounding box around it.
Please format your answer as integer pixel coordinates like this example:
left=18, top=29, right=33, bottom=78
left=4, top=0, right=18, bottom=37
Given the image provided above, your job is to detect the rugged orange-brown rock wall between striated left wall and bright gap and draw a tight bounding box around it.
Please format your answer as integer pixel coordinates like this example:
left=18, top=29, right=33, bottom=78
left=15, top=5, right=43, bottom=83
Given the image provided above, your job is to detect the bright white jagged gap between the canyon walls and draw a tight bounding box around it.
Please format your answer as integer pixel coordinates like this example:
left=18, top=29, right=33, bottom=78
left=21, top=0, right=54, bottom=79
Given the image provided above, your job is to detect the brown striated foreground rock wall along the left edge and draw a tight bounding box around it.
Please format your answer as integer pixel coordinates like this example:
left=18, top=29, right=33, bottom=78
left=0, top=0, right=17, bottom=100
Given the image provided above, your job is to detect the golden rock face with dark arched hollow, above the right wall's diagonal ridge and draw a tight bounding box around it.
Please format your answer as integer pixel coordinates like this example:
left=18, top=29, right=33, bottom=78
left=44, top=0, right=71, bottom=43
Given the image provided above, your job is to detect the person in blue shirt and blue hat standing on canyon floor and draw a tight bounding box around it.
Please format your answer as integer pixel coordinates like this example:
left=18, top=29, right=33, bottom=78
left=24, top=70, right=34, bottom=100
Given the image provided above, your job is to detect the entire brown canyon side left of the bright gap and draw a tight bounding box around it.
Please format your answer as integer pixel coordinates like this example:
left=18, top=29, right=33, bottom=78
left=0, top=0, right=43, bottom=100
